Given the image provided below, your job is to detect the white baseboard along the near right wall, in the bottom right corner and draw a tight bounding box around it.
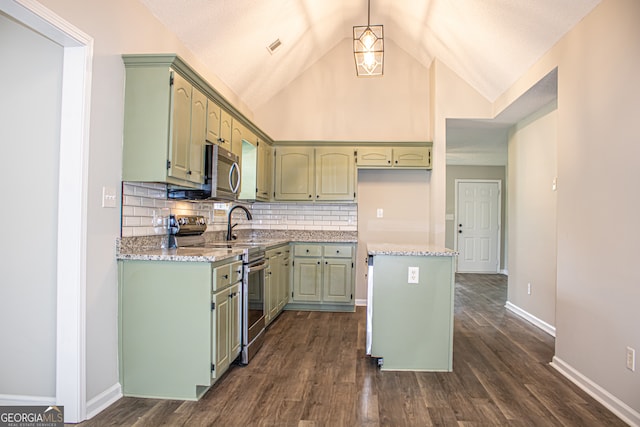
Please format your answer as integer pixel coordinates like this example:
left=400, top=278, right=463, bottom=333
left=549, top=356, right=640, bottom=427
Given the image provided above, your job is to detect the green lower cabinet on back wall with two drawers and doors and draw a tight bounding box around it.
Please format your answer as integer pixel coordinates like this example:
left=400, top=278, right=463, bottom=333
left=287, top=243, right=355, bottom=311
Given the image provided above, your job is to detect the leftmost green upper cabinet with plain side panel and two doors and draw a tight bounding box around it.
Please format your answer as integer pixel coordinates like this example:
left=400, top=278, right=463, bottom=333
left=122, top=57, right=207, bottom=187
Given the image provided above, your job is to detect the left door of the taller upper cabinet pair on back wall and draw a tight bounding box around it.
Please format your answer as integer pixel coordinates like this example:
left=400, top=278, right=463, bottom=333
left=275, top=147, right=315, bottom=200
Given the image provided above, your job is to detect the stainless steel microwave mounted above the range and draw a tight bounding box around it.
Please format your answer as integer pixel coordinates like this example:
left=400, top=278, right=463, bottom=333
left=167, top=144, right=240, bottom=201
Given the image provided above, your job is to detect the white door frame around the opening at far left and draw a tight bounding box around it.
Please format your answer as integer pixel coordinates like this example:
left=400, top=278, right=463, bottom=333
left=0, top=0, right=93, bottom=423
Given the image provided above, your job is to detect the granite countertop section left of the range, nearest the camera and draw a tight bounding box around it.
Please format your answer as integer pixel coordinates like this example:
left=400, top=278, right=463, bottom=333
left=116, top=248, right=244, bottom=262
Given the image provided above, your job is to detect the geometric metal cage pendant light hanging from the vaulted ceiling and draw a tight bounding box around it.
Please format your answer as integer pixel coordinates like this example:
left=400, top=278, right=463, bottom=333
left=353, top=2, right=384, bottom=77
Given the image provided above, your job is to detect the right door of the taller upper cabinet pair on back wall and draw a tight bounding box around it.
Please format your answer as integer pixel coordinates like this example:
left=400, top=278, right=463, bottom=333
left=315, top=147, right=355, bottom=200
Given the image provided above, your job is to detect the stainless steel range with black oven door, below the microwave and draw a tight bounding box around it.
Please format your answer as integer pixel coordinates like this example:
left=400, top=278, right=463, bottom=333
left=176, top=215, right=266, bottom=364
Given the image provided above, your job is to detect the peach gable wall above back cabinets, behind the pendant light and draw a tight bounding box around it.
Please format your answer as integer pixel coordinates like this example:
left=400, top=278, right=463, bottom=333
left=254, top=39, right=430, bottom=141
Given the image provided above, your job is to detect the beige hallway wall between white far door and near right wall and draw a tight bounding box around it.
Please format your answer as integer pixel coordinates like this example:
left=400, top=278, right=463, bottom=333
left=507, top=102, right=558, bottom=326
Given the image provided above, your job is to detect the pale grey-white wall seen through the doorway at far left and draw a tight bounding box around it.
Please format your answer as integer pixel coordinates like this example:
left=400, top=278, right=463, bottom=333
left=0, top=10, right=63, bottom=400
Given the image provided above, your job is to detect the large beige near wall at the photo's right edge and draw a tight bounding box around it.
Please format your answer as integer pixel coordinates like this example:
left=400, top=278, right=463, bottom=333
left=495, top=0, right=640, bottom=424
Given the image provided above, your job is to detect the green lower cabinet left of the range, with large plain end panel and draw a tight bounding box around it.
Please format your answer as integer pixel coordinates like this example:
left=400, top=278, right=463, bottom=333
left=118, top=259, right=240, bottom=400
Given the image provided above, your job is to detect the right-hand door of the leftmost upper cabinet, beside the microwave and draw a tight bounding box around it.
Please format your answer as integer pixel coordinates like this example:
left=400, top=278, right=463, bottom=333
left=187, top=87, right=207, bottom=184
